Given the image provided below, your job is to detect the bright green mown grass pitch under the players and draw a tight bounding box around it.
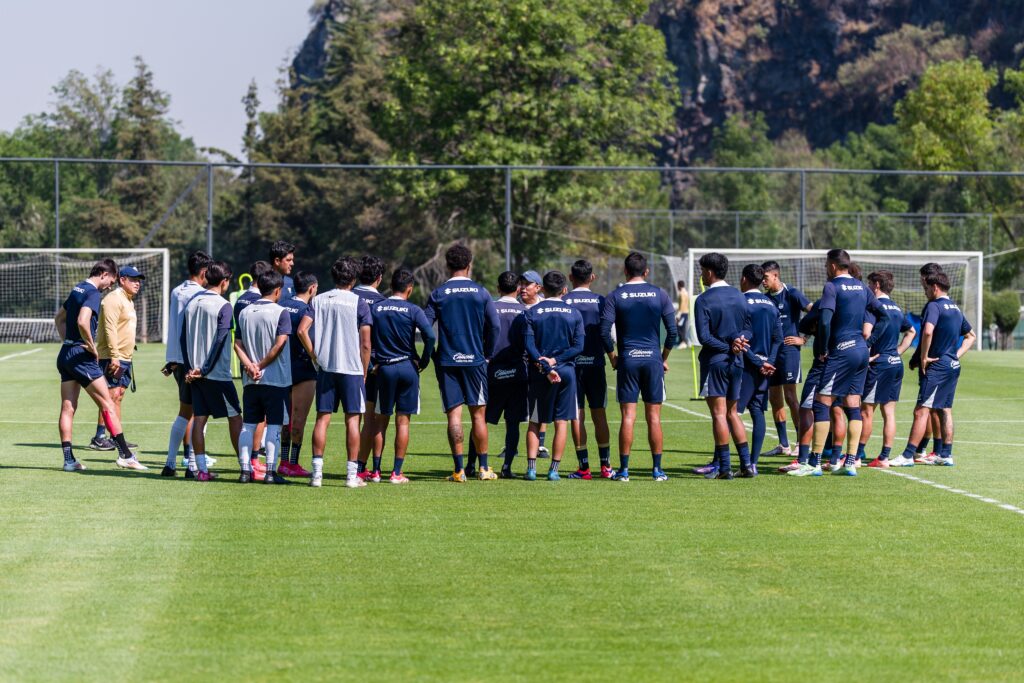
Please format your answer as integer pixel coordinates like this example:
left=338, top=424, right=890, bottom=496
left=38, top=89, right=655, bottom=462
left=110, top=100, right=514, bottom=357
left=0, top=345, right=1024, bottom=681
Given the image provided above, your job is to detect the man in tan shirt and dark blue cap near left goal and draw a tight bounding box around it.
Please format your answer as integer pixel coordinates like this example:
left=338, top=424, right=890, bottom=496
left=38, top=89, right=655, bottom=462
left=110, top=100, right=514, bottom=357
left=89, top=265, right=145, bottom=458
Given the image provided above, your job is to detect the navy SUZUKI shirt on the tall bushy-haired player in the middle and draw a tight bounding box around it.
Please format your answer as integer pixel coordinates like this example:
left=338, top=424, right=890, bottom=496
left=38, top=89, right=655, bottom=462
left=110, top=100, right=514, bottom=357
left=423, top=278, right=501, bottom=368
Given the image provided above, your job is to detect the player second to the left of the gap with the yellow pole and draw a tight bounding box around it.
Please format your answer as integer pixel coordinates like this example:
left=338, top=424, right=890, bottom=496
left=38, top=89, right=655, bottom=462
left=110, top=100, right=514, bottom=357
left=565, top=259, right=610, bottom=479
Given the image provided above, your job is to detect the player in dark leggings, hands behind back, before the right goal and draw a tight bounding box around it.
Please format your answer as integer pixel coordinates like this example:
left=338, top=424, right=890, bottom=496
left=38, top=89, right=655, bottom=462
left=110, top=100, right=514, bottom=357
left=736, top=263, right=782, bottom=478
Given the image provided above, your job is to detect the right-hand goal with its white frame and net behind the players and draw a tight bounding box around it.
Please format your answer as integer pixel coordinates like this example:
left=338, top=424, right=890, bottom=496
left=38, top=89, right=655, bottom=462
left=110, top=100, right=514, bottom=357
left=687, top=249, right=983, bottom=348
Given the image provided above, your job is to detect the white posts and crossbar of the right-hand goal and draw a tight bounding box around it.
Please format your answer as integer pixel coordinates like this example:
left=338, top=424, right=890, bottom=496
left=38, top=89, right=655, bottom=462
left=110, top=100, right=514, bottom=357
left=686, top=247, right=985, bottom=350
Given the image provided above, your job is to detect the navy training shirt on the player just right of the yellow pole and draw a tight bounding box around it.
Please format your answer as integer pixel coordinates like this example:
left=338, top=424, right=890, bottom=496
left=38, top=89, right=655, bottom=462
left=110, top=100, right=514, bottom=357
left=693, top=281, right=754, bottom=365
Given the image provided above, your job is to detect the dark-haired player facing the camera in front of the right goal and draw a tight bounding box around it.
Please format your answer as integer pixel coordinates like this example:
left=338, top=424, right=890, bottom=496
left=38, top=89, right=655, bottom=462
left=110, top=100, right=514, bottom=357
left=761, top=261, right=811, bottom=462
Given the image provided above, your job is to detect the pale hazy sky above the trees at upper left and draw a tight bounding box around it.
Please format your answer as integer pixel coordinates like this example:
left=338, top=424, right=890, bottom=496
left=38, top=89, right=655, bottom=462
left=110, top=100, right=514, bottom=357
left=0, top=0, right=312, bottom=155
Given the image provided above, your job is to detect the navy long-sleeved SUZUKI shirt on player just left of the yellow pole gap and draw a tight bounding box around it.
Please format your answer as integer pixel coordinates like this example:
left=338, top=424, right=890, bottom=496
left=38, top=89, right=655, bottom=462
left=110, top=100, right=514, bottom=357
left=601, top=282, right=679, bottom=357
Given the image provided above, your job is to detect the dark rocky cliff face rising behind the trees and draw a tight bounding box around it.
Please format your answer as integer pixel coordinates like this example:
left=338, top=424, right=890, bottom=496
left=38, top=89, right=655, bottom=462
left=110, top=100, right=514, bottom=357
left=294, top=0, right=1024, bottom=165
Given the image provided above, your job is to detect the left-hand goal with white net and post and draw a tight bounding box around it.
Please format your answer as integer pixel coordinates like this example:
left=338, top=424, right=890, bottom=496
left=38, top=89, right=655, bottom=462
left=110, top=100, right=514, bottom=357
left=0, top=249, right=170, bottom=343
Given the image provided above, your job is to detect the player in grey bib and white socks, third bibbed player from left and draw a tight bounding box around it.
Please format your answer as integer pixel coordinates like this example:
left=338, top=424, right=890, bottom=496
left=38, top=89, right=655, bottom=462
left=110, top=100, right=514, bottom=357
left=234, top=270, right=292, bottom=484
